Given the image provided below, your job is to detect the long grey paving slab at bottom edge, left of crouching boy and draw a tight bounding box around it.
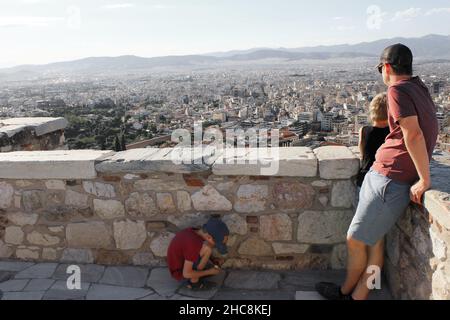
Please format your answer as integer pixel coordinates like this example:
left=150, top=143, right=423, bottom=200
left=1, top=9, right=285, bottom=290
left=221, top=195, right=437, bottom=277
left=86, top=284, right=153, bottom=300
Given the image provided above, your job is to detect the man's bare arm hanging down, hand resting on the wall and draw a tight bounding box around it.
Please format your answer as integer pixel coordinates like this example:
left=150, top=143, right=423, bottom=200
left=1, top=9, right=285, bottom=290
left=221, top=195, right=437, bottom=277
left=398, top=116, right=431, bottom=204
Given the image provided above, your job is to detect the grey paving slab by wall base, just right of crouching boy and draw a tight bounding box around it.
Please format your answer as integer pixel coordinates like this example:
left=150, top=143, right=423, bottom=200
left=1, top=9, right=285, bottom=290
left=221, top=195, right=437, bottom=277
left=225, top=271, right=281, bottom=290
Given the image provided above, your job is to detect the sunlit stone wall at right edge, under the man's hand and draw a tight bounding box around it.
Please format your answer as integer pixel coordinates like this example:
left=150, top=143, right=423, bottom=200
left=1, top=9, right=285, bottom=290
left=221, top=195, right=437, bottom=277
left=386, top=154, right=450, bottom=300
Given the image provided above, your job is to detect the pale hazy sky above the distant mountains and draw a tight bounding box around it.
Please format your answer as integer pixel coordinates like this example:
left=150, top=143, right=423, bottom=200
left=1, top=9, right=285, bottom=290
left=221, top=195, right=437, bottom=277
left=0, top=0, right=450, bottom=67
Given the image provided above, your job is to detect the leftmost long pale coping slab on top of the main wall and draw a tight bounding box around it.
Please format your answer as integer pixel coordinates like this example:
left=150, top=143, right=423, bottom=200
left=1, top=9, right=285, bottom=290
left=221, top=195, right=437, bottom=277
left=0, top=150, right=112, bottom=179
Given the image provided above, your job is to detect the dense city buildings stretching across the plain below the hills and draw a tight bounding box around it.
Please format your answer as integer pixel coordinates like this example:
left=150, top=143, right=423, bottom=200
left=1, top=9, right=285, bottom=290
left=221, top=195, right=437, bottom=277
left=0, top=58, right=450, bottom=150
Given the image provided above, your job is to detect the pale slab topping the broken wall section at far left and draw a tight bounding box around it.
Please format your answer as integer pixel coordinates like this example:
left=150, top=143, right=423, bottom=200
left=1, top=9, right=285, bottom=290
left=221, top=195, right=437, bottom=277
left=0, top=118, right=68, bottom=138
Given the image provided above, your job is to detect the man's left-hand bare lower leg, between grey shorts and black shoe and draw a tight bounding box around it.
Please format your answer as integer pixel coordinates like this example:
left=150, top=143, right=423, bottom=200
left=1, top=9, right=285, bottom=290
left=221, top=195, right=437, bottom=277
left=341, top=237, right=368, bottom=295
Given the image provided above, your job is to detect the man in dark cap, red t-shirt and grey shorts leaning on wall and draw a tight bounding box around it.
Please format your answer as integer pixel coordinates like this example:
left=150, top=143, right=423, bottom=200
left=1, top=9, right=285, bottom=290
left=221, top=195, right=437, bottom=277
left=316, top=44, right=439, bottom=300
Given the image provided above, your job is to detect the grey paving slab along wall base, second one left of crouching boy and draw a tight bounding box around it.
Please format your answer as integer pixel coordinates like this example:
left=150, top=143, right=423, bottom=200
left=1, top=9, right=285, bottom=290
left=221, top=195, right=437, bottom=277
left=100, top=267, right=149, bottom=288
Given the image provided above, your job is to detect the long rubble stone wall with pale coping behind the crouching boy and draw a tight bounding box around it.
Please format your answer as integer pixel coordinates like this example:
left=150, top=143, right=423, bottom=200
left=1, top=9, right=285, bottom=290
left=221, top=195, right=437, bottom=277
left=0, top=147, right=359, bottom=269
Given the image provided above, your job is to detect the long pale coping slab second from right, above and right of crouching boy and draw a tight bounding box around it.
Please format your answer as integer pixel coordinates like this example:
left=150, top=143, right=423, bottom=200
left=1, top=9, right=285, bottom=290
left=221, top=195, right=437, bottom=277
left=212, top=147, right=317, bottom=177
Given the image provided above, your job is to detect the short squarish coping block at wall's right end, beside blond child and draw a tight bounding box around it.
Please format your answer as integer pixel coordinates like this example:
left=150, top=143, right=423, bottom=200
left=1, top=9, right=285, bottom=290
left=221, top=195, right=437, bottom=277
left=314, top=146, right=360, bottom=180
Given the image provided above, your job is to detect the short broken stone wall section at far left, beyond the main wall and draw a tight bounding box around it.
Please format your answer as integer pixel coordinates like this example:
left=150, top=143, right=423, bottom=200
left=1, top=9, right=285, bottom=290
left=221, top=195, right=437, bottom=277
left=0, top=118, right=67, bottom=152
